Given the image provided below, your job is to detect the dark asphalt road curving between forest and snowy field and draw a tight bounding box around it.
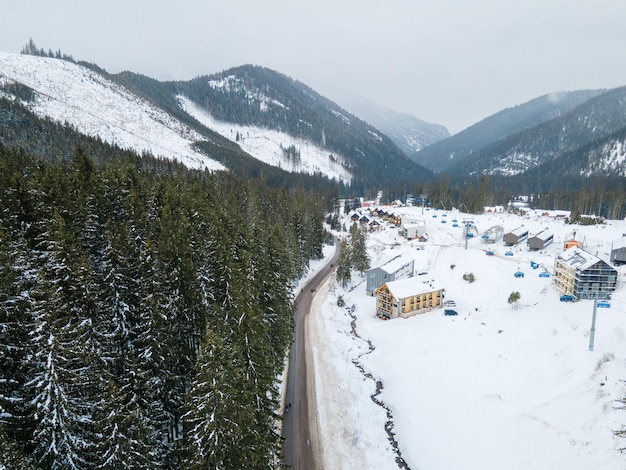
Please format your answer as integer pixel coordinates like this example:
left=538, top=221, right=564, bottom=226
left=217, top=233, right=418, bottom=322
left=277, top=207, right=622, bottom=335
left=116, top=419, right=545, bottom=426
left=282, top=242, right=339, bottom=470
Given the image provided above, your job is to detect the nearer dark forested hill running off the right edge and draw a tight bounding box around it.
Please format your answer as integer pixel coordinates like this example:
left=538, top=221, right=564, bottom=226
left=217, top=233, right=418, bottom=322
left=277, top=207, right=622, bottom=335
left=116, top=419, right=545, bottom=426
left=448, top=87, right=626, bottom=180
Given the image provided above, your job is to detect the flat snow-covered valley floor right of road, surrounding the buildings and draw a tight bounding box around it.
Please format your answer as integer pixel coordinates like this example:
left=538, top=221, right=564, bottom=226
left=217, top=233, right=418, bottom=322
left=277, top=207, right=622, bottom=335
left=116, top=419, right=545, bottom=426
left=308, top=208, right=626, bottom=470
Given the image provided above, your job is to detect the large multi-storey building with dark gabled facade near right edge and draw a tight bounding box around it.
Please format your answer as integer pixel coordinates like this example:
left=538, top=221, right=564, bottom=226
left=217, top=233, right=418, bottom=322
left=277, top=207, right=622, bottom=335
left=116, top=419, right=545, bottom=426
left=554, top=247, right=617, bottom=300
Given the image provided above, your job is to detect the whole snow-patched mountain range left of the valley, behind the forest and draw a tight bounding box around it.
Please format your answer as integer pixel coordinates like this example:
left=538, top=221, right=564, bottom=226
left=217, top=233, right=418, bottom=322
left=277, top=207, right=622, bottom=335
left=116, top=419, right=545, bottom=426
left=0, top=53, right=431, bottom=186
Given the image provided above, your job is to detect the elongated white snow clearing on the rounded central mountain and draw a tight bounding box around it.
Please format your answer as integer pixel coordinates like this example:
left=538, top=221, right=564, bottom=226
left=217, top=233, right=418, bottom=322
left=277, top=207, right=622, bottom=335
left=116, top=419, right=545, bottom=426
left=178, top=96, right=352, bottom=184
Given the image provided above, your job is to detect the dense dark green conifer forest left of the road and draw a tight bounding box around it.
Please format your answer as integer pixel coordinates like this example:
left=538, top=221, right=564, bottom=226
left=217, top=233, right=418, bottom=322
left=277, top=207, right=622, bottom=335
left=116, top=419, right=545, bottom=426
left=0, top=145, right=325, bottom=469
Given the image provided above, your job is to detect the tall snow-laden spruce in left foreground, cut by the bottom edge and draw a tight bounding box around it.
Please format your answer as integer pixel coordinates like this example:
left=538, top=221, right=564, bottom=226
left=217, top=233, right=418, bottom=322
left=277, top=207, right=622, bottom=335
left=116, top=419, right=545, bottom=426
left=27, top=212, right=99, bottom=469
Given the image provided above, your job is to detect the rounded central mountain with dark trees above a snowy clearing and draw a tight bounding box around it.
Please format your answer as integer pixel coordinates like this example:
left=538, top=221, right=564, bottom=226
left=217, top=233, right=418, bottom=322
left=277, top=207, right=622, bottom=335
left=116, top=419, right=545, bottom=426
left=173, top=65, right=432, bottom=191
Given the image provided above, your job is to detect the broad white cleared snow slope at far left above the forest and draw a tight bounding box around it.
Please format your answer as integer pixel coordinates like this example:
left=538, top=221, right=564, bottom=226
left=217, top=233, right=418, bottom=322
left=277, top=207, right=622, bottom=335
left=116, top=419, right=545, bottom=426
left=0, top=52, right=224, bottom=170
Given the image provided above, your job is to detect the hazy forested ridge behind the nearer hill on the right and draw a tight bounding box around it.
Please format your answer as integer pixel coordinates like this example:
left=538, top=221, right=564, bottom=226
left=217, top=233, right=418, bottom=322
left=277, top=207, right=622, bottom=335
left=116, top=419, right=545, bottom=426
left=416, top=90, right=604, bottom=174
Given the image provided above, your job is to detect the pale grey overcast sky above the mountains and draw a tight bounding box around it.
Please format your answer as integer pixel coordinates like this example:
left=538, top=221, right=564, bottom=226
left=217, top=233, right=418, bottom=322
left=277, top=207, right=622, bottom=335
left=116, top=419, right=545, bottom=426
left=0, top=0, right=626, bottom=133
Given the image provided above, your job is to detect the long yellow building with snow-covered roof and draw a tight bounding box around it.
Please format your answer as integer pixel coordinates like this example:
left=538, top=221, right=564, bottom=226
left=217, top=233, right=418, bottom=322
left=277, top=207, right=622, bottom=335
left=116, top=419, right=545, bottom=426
left=374, top=276, right=443, bottom=319
